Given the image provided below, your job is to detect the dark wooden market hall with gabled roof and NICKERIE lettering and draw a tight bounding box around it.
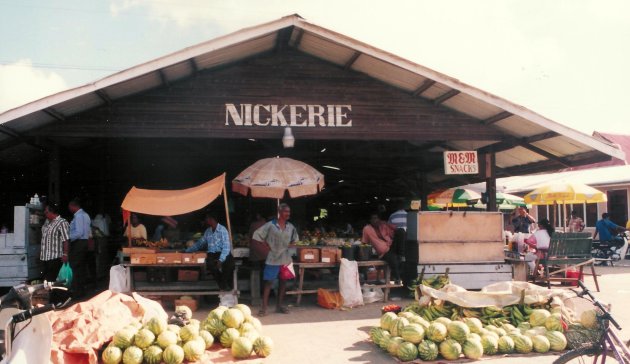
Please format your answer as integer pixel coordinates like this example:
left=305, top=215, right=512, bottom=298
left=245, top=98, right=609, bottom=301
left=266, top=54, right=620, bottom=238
left=0, top=15, right=623, bottom=230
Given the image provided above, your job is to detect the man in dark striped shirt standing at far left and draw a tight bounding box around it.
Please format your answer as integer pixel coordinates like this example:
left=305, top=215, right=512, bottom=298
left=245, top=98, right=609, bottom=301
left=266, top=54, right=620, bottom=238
left=39, top=204, right=70, bottom=282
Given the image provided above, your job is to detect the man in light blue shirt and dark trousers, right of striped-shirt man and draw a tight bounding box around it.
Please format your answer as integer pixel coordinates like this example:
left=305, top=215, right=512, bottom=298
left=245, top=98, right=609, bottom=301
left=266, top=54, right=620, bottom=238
left=68, top=198, right=92, bottom=299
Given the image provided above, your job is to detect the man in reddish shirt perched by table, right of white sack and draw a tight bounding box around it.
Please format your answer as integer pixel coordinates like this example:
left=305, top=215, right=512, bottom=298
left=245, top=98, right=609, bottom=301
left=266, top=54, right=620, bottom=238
left=361, top=213, right=401, bottom=284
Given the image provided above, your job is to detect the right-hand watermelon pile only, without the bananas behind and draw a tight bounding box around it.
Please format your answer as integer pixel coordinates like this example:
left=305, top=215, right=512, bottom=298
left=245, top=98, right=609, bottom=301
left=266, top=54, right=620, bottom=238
left=370, top=309, right=594, bottom=361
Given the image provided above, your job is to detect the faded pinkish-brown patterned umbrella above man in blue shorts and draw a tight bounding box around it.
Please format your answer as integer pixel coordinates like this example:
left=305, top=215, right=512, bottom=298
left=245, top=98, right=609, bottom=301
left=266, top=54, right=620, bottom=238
left=232, top=158, right=324, bottom=199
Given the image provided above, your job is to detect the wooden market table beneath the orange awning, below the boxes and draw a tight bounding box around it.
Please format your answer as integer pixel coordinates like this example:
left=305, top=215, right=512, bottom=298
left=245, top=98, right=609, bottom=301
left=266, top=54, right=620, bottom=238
left=123, top=259, right=243, bottom=296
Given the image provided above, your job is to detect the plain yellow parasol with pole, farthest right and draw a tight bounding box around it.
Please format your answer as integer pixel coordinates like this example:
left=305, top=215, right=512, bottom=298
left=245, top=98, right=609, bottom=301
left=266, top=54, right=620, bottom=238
left=525, top=182, right=608, bottom=231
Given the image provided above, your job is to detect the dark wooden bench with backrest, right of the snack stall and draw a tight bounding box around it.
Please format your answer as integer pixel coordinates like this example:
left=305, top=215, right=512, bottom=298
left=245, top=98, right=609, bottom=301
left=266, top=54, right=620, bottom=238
left=534, top=232, right=599, bottom=292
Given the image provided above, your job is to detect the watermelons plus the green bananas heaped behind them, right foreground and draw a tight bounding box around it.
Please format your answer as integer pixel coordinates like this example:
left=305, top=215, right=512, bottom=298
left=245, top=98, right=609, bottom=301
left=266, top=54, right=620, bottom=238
left=370, top=302, right=572, bottom=361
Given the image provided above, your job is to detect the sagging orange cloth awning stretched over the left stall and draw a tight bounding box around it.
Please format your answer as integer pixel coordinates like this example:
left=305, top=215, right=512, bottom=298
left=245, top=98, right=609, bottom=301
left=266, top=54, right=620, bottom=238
left=121, top=173, right=225, bottom=216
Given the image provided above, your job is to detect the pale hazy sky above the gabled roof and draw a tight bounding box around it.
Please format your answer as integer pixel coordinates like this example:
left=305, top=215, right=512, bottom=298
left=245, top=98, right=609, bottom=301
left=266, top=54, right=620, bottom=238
left=0, top=0, right=630, bottom=134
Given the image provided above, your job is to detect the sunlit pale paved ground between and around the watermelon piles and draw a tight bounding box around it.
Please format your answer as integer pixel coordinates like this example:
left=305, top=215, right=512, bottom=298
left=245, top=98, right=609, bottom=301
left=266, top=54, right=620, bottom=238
left=188, top=261, right=630, bottom=364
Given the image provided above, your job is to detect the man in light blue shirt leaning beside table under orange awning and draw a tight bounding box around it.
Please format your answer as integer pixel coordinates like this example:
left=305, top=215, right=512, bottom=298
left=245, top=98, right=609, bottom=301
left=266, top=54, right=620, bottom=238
left=186, top=213, right=234, bottom=291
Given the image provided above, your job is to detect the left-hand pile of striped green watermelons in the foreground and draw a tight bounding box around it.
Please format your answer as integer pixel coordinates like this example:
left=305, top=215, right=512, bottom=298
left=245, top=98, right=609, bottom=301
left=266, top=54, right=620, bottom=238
left=101, top=304, right=273, bottom=364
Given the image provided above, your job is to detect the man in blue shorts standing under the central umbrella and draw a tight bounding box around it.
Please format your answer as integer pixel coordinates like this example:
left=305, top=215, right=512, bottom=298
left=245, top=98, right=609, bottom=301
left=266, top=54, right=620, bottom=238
left=252, top=203, right=298, bottom=316
